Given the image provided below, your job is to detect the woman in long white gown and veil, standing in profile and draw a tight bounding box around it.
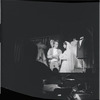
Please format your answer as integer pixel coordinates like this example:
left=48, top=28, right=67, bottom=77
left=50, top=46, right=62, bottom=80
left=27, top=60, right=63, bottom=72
left=60, top=41, right=73, bottom=73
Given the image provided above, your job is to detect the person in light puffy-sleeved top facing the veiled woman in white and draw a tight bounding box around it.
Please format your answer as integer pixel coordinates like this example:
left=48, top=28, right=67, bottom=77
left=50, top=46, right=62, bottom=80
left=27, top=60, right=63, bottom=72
left=47, top=41, right=62, bottom=71
